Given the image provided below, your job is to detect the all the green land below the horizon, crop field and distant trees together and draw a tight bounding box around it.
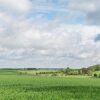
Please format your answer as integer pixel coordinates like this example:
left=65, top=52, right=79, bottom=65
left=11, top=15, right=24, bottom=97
left=0, top=66, right=100, bottom=100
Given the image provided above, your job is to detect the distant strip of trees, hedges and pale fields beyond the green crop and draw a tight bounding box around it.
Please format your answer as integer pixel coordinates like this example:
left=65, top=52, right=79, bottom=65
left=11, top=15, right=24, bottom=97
left=16, top=65, right=100, bottom=77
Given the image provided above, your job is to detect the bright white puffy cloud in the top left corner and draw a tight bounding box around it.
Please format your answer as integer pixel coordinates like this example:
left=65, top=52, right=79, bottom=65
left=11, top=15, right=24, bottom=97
left=0, top=0, right=31, bottom=12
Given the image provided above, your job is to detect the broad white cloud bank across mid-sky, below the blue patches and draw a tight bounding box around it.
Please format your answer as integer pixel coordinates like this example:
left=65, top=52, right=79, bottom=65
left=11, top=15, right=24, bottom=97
left=0, top=17, right=100, bottom=66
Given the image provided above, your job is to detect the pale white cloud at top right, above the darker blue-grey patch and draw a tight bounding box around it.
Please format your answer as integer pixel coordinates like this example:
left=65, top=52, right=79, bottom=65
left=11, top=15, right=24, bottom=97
left=68, top=0, right=100, bottom=12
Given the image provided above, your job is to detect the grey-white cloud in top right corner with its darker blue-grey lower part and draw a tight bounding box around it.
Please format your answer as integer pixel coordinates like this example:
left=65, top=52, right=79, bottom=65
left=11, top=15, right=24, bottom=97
left=68, top=0, right=100, bottom=25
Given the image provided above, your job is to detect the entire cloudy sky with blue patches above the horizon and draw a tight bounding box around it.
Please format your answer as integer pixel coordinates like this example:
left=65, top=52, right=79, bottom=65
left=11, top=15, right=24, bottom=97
left=0, top=0, right=100, bottom=68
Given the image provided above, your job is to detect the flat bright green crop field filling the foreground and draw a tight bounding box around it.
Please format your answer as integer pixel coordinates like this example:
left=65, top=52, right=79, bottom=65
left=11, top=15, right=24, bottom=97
left=0, top=70, right=100, bottom=100
